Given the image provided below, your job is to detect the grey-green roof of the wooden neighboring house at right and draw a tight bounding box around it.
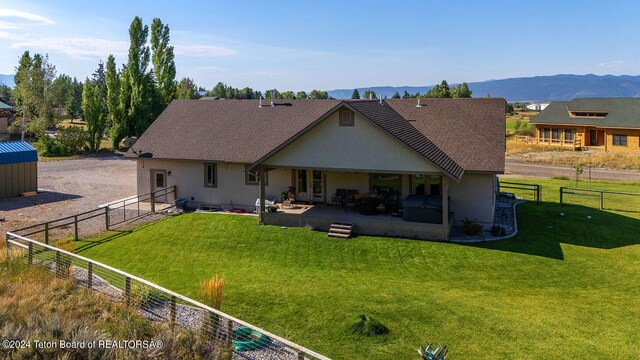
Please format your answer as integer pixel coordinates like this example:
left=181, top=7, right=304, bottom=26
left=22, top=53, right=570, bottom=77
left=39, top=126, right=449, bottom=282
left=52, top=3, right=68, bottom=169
left=531, top=98, right=640, bottom=129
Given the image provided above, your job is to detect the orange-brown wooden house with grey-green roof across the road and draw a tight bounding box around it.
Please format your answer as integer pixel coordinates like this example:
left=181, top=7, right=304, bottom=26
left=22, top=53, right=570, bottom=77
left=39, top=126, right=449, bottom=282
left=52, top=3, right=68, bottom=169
left=531, top=98, right=640, bottom=151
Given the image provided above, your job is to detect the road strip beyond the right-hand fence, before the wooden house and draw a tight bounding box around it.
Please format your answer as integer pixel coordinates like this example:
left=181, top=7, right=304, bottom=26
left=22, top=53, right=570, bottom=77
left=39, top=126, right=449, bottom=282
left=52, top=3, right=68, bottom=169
left=501, top=158, right=640, bottom=181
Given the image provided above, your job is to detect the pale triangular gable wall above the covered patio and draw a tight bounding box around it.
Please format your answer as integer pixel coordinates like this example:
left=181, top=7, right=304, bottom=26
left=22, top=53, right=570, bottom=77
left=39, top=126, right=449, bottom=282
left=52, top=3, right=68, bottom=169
left=263, top=112, right=441, bottom=173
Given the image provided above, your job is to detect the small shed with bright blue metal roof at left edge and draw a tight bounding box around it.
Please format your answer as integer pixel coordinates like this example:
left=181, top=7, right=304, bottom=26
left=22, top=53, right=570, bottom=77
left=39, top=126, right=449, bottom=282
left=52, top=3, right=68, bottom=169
left=0, top=141, right=38, bottom=199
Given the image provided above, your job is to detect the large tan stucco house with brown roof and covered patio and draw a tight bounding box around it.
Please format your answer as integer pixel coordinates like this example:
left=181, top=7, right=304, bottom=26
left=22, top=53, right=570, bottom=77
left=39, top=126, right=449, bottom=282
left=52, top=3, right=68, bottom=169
left=127, top=99, right=505, bottom=239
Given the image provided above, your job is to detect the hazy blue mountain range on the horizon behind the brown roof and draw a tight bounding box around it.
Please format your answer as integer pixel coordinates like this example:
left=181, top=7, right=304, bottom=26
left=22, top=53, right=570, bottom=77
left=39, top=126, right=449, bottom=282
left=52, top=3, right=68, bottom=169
left=329, top=74, right=640, bottom=101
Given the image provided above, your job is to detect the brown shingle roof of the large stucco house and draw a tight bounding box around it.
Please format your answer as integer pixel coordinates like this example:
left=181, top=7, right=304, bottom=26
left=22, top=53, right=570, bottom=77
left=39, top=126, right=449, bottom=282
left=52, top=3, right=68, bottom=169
left=127, top=99, right=505, bottom=178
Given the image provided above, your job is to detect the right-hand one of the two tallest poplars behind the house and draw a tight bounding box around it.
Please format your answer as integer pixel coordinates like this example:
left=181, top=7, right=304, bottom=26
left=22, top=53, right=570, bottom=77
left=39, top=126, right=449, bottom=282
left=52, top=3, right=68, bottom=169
left=151, top=18, right=176, bottom=110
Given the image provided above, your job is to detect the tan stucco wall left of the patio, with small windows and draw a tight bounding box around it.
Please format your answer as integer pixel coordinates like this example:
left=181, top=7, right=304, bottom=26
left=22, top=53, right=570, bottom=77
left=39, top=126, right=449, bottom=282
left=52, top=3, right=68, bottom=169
left=137, top=159, right=291, bottom=210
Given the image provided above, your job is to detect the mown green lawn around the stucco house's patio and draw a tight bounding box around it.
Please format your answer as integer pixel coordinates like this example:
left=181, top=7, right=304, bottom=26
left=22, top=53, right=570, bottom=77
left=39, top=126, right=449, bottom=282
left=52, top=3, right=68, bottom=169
left=76, top=179, right=640, bottom=359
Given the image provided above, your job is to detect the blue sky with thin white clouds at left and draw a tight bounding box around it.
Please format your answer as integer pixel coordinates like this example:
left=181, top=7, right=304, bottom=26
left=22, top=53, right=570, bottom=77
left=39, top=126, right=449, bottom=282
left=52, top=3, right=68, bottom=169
left=0, top=0, right=640, bottom=91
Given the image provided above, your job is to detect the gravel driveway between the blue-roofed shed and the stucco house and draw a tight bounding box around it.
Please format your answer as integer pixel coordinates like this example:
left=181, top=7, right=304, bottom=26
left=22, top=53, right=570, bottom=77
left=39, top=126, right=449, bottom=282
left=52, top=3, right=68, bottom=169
left=0, top=156, right=136, bottom=237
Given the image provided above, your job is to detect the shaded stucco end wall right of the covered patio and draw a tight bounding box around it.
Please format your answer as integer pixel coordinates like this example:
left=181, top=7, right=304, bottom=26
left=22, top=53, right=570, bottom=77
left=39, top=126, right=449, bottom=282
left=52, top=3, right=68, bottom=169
left=449, top=172, right=496, bottom=227
